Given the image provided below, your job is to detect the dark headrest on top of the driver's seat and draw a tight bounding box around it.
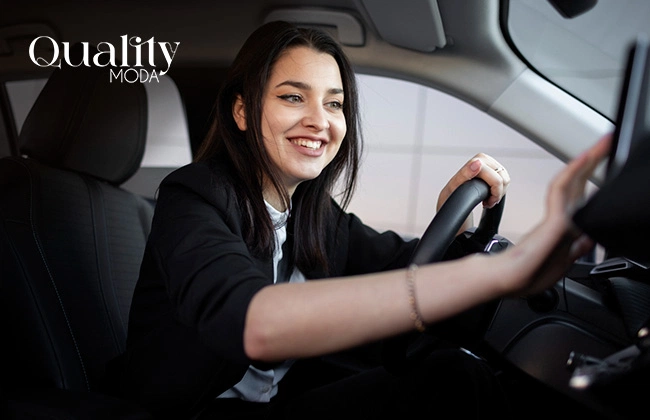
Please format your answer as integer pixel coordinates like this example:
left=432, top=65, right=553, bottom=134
left=18, top=44, right=147, bottom=185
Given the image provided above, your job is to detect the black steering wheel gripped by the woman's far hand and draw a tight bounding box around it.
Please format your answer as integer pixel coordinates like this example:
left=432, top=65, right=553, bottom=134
left=382, top=178, right=505, bottom=371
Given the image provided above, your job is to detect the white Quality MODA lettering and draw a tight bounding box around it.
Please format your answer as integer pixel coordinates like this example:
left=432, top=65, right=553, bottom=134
left=29, top=35, right=180, bottom=83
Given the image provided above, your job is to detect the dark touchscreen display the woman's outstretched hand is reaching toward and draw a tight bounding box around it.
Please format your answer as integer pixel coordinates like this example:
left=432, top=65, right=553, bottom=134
left=573, top=35, right=650, bottom=266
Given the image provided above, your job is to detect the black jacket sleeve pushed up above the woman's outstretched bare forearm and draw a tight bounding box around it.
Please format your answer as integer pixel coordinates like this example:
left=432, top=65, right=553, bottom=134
left=130, top=164, right=273, bottom=364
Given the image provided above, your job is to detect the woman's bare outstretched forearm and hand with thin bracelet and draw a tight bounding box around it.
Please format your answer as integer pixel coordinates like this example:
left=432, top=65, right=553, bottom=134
left=244, top=136, right=610, bottom=361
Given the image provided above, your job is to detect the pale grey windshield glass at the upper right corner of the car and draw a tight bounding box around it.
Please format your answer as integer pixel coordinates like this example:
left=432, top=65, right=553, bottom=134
left=507, top=0, right=650, bottom=120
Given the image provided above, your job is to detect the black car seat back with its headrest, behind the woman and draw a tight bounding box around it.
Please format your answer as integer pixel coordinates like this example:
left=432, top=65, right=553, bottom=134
left=0, top=52, right=153, bottom=391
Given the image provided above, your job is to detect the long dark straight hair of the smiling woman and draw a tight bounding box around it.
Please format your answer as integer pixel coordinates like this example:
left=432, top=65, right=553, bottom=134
left=195, top=22, right=362, bottom=273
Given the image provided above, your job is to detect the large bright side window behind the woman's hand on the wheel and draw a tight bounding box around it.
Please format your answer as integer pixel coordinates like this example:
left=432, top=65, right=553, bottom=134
left=348, top=75, right=576, bottom=243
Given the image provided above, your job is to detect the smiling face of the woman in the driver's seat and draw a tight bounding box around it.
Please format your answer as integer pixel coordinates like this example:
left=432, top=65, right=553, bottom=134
left=235, top=47, right=346, bottom=194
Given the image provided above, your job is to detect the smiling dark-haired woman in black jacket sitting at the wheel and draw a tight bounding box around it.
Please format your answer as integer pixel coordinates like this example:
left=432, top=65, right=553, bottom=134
left=92, top=17, right=607, bottom=419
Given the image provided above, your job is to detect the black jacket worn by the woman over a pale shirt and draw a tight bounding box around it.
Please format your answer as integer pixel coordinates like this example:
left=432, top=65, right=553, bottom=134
left=104, top=163, right=416, bottom=413
